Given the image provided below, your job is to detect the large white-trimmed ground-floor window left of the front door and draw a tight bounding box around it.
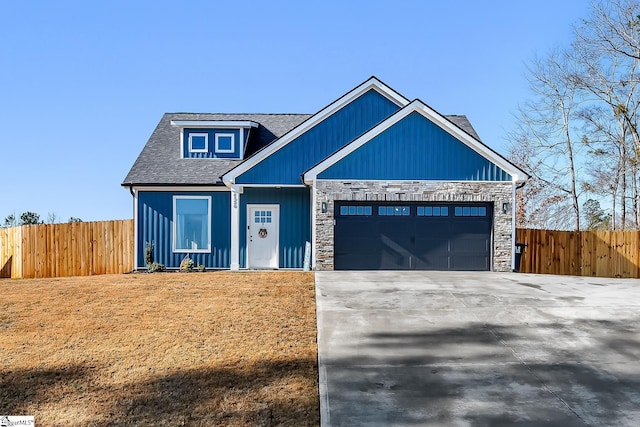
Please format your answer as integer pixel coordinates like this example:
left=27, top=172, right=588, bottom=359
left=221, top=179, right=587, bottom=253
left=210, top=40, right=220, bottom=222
left=173, top=196, right=211, bottom=253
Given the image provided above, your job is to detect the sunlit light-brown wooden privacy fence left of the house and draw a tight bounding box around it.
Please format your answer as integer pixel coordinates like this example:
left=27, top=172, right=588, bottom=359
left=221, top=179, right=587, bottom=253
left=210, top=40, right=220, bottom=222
left=0, top=220, right=134, bottom=278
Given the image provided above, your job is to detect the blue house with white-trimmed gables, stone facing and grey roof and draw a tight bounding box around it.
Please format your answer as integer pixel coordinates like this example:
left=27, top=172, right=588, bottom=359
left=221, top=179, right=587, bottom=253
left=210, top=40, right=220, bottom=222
left=122, top=77, right=527, bottom=271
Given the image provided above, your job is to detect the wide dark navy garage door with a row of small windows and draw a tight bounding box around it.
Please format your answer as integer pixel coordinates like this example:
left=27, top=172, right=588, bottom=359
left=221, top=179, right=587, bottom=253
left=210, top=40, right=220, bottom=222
left=334, top=201, right=493, bottom=270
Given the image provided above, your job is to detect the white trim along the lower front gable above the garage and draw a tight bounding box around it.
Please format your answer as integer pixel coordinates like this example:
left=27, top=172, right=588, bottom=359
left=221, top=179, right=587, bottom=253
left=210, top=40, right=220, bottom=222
left=304, top=99, right=528, bottom=185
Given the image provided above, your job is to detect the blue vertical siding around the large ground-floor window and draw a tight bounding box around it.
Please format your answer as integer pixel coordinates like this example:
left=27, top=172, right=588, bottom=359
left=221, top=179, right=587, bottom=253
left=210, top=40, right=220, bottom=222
left=137, top=191, right=231, bottom=268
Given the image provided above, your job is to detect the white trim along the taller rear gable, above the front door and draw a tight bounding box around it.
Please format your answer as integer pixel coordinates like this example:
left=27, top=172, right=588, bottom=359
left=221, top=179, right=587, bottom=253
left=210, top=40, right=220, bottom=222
left=222, top=77, right=409, bottom=186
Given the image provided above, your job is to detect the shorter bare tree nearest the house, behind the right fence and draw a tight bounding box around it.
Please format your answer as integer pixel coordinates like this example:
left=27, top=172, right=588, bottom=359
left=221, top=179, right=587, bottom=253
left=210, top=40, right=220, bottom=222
left=509, top=50, right=581, bottom=230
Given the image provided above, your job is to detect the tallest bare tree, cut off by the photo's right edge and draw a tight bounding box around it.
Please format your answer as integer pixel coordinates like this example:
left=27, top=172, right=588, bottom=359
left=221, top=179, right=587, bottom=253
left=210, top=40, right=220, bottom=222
left=572, top=0, right=640, bottom=229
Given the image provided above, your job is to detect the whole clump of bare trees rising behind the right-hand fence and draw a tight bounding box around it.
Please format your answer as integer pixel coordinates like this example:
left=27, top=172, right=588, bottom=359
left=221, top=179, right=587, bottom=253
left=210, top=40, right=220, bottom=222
left=509, top=0, right=640, bottom=229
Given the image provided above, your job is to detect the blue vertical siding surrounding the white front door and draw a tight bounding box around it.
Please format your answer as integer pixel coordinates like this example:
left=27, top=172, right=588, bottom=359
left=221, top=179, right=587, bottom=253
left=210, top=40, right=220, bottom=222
left=240, top=188, right=311, bottom=268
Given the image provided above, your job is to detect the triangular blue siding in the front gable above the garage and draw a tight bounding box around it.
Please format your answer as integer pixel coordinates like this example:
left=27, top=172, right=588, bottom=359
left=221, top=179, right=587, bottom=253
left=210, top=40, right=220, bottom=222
left=318, top=112, right=511, bottom=181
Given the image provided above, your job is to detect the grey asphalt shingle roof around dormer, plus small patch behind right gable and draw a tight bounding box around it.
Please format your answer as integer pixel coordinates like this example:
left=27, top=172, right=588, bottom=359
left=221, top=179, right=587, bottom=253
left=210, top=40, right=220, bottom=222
left=122, top=113, right=480, bottom=186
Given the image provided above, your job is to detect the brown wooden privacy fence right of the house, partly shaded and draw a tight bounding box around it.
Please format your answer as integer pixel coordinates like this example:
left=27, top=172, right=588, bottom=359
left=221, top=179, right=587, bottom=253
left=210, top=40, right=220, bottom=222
left=516, top=228, right=640, bottom=278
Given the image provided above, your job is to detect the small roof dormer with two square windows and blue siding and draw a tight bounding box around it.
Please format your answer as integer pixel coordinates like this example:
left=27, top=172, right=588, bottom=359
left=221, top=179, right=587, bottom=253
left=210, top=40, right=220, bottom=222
left=171, top=120, right=258, bottom=159
